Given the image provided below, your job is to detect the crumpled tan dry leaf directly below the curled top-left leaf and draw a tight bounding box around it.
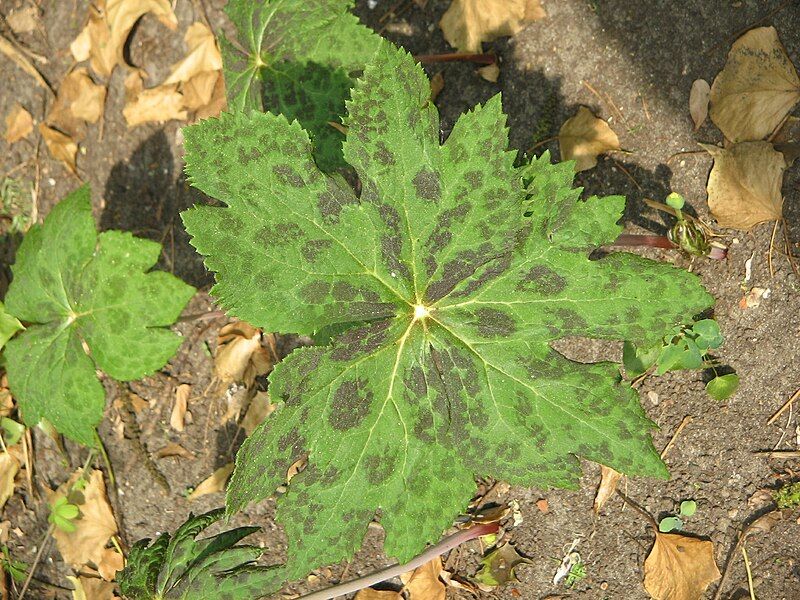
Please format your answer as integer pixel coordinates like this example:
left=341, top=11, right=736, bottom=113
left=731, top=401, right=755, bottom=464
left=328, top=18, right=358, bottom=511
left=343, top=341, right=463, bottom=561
left=45, top=67, right=106, bottom=142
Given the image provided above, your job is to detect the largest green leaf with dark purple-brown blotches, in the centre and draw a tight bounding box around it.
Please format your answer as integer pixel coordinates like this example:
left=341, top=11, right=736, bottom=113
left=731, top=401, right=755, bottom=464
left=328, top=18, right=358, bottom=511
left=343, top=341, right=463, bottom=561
left=184, top=44, right=712, bottom=579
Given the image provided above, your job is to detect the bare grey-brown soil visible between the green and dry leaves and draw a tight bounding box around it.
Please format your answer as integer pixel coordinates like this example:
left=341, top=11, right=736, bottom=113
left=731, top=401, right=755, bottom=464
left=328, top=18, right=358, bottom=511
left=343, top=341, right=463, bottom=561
left=0, top=0, right=800, bottom=600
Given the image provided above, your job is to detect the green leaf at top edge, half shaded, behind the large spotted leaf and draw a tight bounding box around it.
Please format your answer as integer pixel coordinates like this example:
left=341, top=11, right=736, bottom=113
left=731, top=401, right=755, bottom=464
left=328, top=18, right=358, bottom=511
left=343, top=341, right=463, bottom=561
left=222, top=0, right=381, bottom=171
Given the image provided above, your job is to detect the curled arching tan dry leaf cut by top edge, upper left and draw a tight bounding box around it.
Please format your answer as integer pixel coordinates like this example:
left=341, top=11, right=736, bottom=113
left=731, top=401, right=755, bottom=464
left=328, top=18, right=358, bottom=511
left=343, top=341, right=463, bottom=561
left=70, top=0, right=178, bottom=78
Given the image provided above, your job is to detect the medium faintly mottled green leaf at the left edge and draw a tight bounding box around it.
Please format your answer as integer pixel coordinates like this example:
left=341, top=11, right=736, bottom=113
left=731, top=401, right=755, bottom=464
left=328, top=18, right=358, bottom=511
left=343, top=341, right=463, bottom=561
left=5, top=186, right=194, bottom=445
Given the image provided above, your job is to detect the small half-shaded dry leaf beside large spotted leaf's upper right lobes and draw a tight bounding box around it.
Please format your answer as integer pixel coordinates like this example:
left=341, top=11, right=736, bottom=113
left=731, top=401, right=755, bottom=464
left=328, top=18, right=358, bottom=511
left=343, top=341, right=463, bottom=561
left=558, top=106, right=619, bottom=171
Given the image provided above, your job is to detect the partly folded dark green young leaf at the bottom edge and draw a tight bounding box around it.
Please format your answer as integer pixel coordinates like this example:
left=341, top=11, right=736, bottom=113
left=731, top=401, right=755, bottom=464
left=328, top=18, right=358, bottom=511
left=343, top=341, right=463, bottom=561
left=117, top=509, right=280, bottom=600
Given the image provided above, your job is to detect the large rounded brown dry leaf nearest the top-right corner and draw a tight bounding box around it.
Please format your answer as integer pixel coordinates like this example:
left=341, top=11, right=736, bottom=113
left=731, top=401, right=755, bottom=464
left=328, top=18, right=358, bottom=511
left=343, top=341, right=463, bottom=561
left=711, top=27, right=800, bottom=142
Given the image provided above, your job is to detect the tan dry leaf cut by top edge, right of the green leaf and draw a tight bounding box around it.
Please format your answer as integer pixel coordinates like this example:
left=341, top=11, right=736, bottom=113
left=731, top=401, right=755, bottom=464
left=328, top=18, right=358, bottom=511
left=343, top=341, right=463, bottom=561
left=439, top=0, right=546, bottom=53
